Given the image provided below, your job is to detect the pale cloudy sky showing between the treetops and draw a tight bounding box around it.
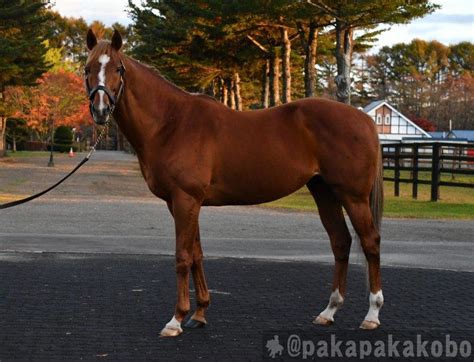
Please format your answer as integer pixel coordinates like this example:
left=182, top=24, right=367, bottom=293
left=54, top=0, right=474, bottom=49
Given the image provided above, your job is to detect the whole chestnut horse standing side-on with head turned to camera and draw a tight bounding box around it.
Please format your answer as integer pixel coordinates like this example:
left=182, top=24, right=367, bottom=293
left=85, top=30, right=383, bottom=336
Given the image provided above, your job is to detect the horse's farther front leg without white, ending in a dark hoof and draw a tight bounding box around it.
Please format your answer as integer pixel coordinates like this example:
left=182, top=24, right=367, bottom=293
left=184, top=227, right=210, bottom=328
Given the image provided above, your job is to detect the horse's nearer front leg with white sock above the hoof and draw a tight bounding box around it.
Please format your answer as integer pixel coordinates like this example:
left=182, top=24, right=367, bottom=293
left=161, top=192, right=201, bottom=337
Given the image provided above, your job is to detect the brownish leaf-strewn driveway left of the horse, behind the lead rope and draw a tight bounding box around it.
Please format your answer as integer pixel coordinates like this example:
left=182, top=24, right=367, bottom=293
left=0, top=151, right=154, bottom=201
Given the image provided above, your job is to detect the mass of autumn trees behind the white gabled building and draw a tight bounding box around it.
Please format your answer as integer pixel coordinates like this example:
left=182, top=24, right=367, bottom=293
left=367, top=39, right=474, bottom=130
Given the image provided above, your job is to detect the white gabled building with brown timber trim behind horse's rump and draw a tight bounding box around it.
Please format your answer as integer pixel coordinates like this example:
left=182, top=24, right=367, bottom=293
left=362, top=100, right=431, bottom=143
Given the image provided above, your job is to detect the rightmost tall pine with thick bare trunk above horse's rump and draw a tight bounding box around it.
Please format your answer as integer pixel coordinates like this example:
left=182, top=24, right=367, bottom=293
left=307, top=0, right=439, bottom=104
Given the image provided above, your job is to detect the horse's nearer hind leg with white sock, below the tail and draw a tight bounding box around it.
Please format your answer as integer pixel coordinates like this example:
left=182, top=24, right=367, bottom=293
left=344, top=198, right=383, bottom=329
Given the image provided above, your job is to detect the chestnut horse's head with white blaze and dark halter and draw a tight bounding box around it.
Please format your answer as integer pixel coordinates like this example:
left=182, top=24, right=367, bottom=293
left=84, top=29, right=125, bottom=124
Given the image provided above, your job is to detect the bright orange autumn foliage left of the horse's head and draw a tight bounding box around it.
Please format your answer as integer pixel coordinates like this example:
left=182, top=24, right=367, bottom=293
left=7, top=69, right=91, bottom=139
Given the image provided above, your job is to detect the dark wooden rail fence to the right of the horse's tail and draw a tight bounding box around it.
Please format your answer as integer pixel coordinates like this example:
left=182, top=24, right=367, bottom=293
left=381, top=142, right=474, bottom=201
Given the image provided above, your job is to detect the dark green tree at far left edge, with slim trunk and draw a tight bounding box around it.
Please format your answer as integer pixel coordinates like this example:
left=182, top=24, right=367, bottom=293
left=0, top=0, right=48, bottom=157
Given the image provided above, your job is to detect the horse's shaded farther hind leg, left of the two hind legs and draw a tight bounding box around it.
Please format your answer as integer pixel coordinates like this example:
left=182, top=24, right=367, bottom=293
left=306, top=177, right=351, bottom=325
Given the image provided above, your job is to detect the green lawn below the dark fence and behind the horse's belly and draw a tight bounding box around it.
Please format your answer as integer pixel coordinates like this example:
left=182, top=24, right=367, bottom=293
left=263, top=174, right=474, bottom=220
